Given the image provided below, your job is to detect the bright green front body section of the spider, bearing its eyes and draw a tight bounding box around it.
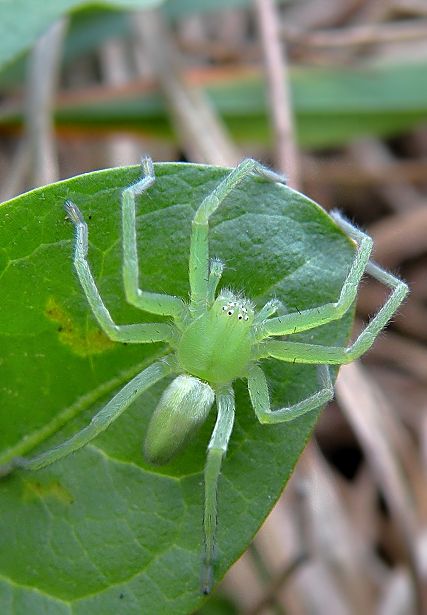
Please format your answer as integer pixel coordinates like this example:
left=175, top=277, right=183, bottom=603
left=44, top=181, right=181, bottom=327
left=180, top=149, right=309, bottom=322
left=178, top=293, right=253, bottom=384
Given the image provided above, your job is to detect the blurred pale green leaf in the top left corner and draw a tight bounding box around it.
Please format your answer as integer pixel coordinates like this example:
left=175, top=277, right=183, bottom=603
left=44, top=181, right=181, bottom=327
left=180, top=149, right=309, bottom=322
left=0, top=0, right=163, bottom=68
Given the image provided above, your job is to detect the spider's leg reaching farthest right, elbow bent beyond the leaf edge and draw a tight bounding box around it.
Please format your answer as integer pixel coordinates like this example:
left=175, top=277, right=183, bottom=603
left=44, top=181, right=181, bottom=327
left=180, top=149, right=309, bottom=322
left=254, top=262, right=408, bottom=365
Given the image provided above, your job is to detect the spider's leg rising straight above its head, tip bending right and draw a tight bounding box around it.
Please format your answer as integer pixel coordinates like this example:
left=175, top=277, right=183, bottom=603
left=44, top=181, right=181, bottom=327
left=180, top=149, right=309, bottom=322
left=189, top=158, right=286, bottom=316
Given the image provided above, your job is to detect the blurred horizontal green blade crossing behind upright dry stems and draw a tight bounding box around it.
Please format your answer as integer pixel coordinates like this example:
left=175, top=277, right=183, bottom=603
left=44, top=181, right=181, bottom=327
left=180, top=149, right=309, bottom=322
left=0, top=62, right=427, bottom=148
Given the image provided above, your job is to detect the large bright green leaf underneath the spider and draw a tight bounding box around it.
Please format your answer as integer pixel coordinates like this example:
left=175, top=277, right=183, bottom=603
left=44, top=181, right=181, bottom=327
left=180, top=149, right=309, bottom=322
left=0, top=163, right=353, bottom=615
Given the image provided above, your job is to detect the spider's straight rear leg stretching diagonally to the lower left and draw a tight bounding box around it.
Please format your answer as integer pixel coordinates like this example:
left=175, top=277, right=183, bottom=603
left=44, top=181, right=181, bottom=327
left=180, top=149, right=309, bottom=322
left=10, top=355, right=174, bottom=470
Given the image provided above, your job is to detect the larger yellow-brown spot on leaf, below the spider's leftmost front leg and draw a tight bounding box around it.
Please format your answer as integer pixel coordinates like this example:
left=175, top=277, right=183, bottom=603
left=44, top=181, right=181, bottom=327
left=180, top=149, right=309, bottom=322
left=45, top=297, right=114, bottom=357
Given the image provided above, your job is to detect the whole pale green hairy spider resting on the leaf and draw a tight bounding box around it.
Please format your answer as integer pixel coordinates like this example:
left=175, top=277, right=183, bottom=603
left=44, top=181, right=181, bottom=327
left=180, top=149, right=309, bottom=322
left=12, top=157, right=408, bottom=594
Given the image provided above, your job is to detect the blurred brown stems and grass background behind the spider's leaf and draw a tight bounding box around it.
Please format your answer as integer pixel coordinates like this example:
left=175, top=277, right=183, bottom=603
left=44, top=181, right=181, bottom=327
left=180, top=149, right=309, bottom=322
left=0, top=0, right=427, bottom=615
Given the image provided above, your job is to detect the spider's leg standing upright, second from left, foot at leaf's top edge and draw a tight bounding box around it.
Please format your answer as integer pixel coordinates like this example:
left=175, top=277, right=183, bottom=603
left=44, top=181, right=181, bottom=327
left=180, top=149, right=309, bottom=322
left=122, top=156, right=185, bottom=324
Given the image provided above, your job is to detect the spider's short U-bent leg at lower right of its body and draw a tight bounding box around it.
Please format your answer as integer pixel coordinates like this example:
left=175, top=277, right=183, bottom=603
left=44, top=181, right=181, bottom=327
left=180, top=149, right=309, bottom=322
left=248, top=364, right=334, bottom=424
